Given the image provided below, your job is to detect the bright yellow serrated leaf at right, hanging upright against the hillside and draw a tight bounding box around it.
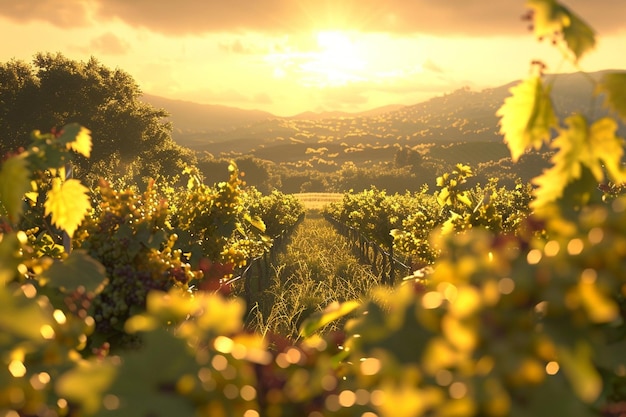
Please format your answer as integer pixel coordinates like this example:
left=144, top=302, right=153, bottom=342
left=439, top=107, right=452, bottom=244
left=496, top=76, right=557, bottom=161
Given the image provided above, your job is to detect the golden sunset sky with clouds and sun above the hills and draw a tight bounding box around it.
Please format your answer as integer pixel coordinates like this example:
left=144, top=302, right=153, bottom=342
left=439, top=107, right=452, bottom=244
left=0, top=0, right=626, bottom=116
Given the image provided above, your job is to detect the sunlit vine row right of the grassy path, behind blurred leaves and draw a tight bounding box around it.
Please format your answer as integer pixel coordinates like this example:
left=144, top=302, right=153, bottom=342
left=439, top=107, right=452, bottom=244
left=324, top=164, right=532, bottom=271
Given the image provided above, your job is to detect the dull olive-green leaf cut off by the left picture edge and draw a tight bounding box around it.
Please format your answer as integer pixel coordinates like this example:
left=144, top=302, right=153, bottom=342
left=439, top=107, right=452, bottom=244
left=0, top=156, right=31, bottom=222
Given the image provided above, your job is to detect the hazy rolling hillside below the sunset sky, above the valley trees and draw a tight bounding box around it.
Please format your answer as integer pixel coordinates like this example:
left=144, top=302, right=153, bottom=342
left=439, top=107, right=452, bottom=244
left=146, top=72, right=626, bottom=185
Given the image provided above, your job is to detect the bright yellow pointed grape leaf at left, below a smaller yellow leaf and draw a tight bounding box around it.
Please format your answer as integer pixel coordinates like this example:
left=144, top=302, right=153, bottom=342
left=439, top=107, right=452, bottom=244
left=44, top=178, right=91, bottom=236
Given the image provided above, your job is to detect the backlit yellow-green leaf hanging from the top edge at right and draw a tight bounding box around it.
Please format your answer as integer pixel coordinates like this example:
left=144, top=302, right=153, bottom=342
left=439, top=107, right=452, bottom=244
left=526, top=0, right=596, bottom=61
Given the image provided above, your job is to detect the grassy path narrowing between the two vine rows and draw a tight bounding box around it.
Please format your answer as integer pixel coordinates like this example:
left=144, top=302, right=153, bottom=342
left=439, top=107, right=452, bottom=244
left=248, top=212, right=379, bottom=338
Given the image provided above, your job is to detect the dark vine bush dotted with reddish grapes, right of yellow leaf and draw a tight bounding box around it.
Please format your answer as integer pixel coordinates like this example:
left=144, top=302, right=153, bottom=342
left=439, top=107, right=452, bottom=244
left=77, top=183, right=196, bottom=348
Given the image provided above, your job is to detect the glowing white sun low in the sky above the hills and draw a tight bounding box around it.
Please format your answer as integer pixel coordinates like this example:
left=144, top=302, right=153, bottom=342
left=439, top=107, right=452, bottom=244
left=301, top=31, right=367, bottom=86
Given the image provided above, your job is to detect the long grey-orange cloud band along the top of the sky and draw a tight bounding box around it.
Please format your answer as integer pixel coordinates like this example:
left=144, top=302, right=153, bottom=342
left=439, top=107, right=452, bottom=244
left=0, top=0, right=626, bottom=36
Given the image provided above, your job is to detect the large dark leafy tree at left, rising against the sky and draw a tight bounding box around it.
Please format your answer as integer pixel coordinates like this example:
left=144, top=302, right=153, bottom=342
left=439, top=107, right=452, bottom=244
left=0, top=53, right=195, bottom=179
